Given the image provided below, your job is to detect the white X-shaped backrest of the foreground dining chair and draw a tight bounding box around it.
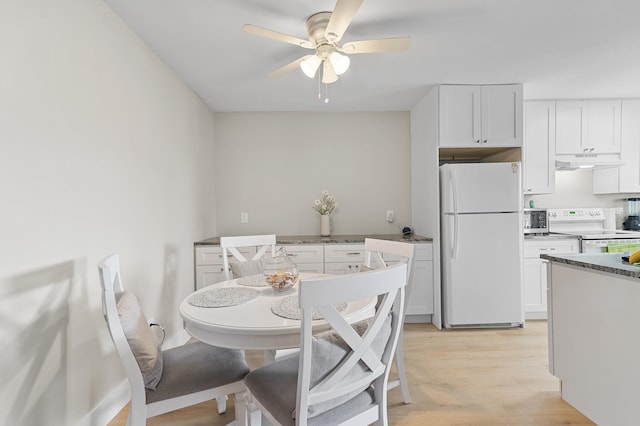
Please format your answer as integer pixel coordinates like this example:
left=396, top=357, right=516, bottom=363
left=296, top=264, right=407, bottom=424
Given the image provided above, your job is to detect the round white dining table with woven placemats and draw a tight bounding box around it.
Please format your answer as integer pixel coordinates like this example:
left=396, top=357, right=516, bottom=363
left=180, top=273, right=376, bottom=351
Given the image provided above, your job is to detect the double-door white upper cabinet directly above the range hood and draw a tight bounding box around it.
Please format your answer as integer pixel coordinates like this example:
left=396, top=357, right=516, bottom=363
left=556, top=100, right=621, bottom=155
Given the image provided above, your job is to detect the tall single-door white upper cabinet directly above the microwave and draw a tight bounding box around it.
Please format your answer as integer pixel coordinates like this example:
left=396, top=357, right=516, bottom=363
left=522, top=101, right=556, bottom=194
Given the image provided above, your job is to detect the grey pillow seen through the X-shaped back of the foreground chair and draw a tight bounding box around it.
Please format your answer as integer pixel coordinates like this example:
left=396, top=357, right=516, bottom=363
left=291, top=316, right=391, bottom=418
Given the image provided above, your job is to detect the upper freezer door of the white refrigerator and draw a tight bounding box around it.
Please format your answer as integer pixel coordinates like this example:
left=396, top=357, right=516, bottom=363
left=440, top=162, right=523, bottom=213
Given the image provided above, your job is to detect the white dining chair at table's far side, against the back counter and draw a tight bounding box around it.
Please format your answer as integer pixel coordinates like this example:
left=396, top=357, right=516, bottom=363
left=220, top=234, right=276, bottom=280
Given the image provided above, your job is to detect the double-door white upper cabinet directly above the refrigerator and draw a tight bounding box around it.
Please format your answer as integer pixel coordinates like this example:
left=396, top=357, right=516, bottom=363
left=439, top=84, right=522, bottom=148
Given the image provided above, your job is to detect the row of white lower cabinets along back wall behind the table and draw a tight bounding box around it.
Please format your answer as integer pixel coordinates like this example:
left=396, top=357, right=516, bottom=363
left=194, top=243, right=440, bottom=322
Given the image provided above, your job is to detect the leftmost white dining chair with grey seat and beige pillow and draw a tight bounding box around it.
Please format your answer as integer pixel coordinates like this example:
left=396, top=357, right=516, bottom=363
left=98, top=254, right=249, bottom=426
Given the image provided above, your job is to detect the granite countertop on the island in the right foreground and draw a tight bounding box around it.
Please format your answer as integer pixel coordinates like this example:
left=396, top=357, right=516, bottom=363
left=540, top=253, right=640, bottom=278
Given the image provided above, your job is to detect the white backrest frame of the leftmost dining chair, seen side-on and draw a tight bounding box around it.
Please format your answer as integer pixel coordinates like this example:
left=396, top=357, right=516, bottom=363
left=98, top=254, right=146, bottom=424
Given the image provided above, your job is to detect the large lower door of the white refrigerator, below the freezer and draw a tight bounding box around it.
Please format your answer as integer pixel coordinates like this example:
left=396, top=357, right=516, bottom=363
left=441, top=213, right=524, bottom=328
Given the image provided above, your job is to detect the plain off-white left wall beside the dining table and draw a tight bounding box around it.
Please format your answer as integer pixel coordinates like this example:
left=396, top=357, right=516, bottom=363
left=0, top=0, right=216, bottom=425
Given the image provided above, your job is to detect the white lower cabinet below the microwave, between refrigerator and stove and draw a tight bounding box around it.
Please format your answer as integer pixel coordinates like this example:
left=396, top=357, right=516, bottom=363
left=524, top=238, right=580, bottom=320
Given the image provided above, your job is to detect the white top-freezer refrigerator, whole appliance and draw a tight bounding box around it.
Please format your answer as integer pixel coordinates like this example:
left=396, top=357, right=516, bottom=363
left=440, top=162, right=524, bottom=328
